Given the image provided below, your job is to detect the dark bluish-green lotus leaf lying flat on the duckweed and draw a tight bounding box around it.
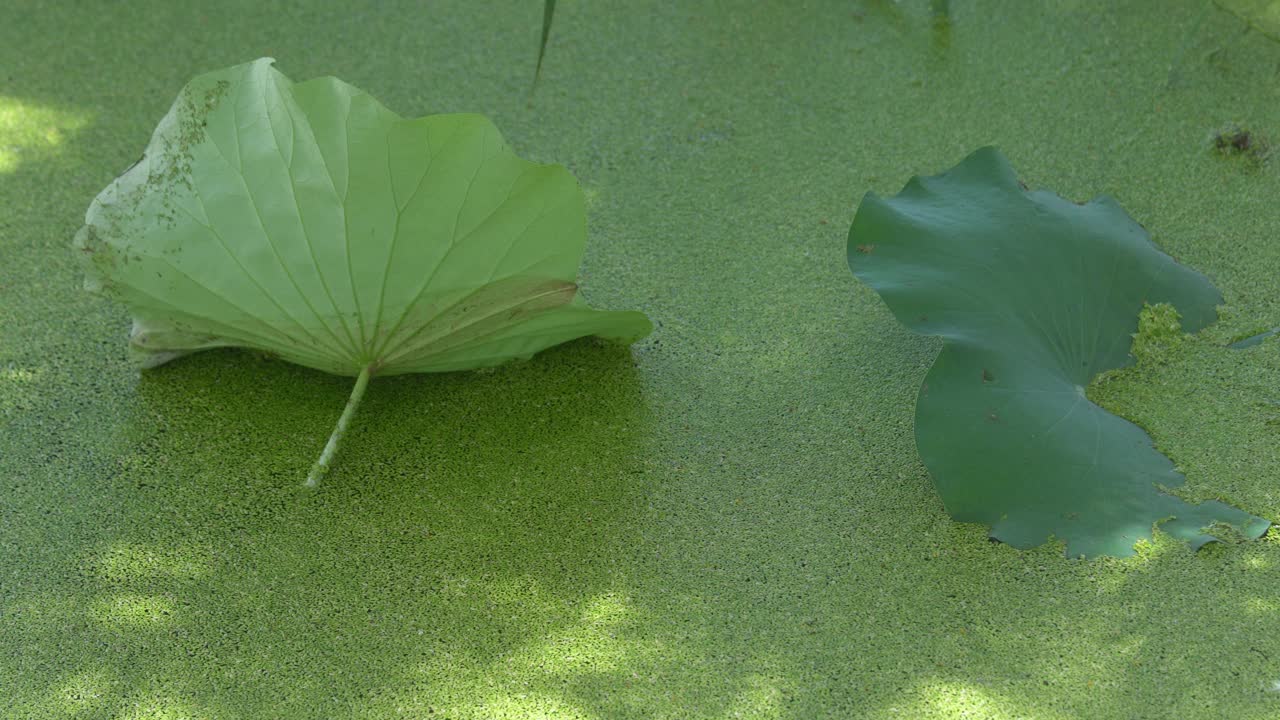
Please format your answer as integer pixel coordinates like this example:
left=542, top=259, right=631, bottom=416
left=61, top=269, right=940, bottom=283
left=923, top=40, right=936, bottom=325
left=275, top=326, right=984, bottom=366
left=849, top=147, right=1268, bottom=556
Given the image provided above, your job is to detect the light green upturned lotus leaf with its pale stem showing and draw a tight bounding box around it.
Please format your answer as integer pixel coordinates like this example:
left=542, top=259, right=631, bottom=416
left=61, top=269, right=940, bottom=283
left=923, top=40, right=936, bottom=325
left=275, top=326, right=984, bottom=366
left=76, top=58, right=652, bottom=484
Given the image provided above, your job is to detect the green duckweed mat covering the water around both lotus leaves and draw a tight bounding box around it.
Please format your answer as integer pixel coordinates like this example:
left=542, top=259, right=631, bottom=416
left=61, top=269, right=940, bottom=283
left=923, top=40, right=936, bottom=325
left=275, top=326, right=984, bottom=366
left=0, top=0, right=1280, bottom=719
